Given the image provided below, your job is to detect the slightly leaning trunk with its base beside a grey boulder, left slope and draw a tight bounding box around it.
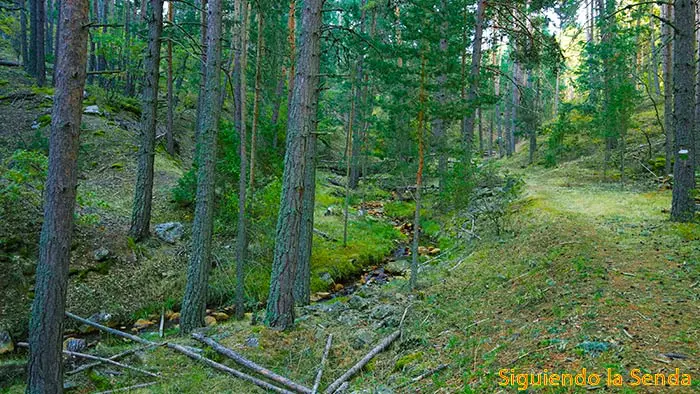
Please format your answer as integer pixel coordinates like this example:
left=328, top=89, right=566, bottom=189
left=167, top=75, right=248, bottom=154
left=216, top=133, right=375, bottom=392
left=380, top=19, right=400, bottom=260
left=129, top=0, right=163, bottom=241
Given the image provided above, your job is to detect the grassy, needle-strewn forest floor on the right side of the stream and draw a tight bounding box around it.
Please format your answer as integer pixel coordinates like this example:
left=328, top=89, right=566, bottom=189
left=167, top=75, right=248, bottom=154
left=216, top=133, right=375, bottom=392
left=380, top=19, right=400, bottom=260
left=4, top=152, right=700, bottom=393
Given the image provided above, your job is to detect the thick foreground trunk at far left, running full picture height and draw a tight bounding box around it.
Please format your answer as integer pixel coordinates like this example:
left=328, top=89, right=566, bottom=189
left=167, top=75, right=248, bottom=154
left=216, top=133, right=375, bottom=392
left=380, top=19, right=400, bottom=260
left=27, top=0, right=88, bottom=394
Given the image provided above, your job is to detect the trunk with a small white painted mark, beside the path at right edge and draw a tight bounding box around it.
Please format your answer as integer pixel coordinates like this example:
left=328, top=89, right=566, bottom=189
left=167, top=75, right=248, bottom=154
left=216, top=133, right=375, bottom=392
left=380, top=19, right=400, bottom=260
left=671, top=0, right=695, bottom=222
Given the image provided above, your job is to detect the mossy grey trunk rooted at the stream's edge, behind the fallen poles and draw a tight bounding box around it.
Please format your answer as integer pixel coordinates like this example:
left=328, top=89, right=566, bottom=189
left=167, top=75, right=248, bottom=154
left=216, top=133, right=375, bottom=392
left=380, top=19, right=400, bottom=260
left=180, top=0, right=221, bottom=333
